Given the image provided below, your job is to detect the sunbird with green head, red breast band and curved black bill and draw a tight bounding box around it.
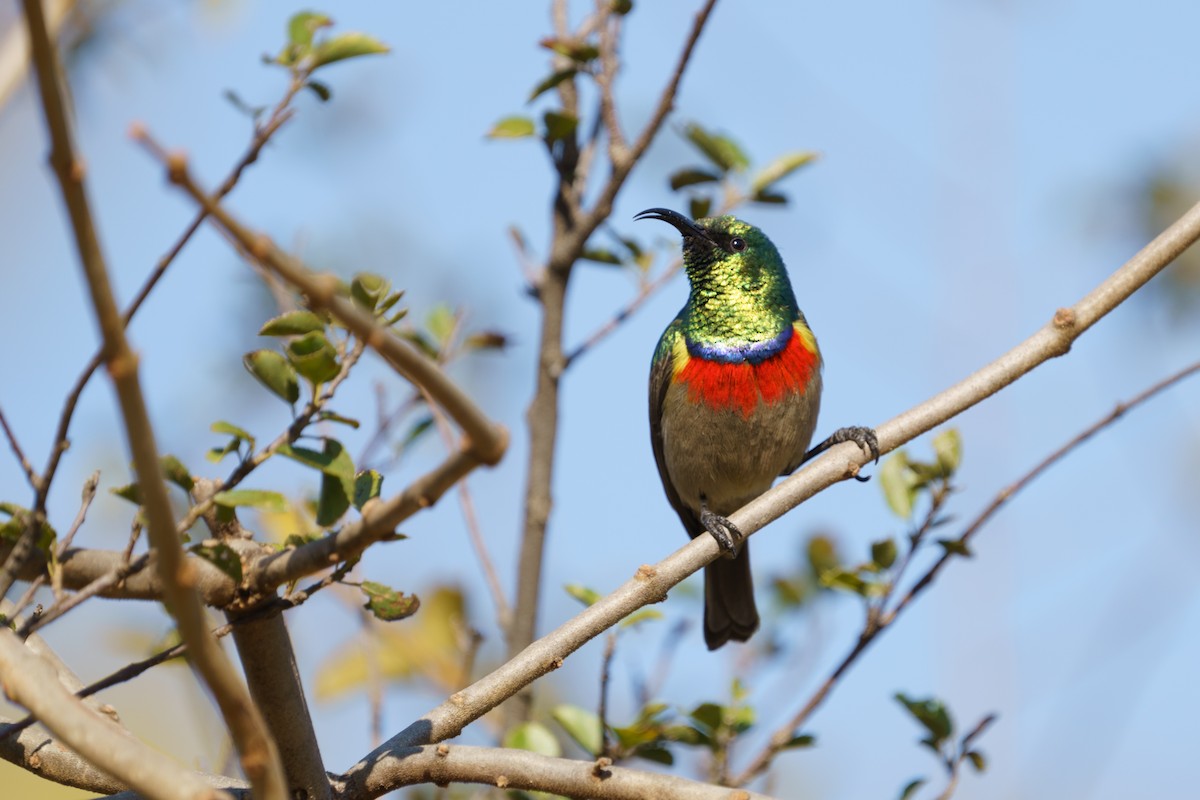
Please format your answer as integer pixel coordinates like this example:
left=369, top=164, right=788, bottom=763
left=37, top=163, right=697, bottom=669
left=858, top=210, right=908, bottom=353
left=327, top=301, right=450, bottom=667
left=634, top=209, right=880, bottom=650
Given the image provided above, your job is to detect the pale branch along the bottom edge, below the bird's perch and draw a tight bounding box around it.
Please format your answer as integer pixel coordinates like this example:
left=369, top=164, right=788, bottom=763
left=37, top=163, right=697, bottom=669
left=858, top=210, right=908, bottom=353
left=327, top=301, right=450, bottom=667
left=336, top=745, right=770, bottom=800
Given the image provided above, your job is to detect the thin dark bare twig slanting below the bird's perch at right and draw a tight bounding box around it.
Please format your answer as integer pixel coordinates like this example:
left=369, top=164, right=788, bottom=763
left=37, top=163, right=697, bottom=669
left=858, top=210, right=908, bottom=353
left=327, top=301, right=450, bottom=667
left=732, top=362, right=1200, bottom=786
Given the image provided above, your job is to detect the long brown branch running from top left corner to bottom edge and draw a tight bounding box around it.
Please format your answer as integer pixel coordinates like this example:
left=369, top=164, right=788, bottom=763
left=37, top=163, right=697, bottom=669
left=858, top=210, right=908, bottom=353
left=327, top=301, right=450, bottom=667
left=23, top=0, right=287, bottom=800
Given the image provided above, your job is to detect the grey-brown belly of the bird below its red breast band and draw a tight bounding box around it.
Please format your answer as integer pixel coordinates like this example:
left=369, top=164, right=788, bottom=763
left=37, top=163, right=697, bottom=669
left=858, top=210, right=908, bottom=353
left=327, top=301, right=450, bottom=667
left=662, top=377, right=821, bottom=516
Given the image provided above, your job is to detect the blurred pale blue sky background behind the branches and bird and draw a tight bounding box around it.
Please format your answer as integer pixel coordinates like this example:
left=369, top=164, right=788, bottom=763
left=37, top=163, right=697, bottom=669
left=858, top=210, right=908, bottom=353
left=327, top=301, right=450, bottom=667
left=0, top=0, right=1200, bottom=799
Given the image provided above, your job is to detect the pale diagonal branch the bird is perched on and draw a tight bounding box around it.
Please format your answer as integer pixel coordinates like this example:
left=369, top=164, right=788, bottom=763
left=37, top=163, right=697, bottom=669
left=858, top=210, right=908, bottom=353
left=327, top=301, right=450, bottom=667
left=356, top=191, right=1200, bottom=769
